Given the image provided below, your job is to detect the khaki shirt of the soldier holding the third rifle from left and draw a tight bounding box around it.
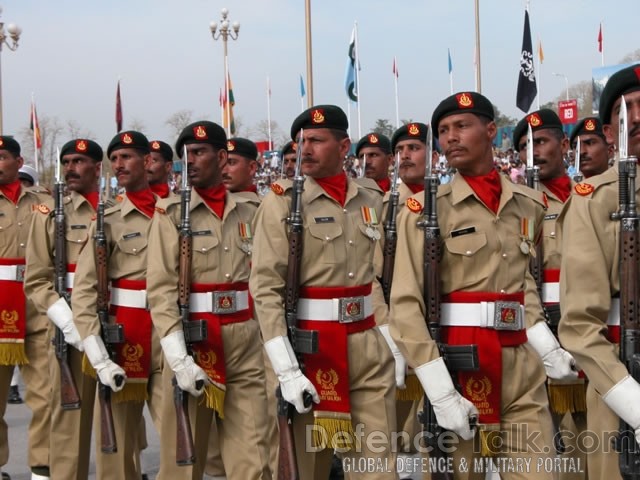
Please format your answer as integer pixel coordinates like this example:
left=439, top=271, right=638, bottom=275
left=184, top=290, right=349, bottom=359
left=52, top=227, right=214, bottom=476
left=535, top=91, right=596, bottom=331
left=147, top=189, right=256, bottom=338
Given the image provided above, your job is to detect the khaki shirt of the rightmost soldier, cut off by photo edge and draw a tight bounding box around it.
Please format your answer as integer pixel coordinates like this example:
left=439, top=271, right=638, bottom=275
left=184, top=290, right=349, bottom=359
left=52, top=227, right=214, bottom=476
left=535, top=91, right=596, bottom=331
left=558, top=166, right=628, bottom=395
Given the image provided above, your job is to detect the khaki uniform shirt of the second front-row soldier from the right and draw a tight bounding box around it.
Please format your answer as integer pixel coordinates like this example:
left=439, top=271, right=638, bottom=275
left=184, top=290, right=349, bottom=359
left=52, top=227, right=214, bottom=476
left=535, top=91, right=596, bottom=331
left=390, top=173, right=544, bottom=368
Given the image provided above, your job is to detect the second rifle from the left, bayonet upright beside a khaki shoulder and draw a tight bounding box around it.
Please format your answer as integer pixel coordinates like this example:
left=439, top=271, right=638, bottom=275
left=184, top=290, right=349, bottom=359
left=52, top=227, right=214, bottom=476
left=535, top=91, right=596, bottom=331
left=94, top=169, right=124, bottom=453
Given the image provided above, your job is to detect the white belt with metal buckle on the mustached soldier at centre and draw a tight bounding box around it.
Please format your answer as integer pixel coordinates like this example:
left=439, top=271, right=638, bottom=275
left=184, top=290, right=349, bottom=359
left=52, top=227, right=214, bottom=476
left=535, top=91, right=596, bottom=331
left=298, top=294, right=373, bottom=323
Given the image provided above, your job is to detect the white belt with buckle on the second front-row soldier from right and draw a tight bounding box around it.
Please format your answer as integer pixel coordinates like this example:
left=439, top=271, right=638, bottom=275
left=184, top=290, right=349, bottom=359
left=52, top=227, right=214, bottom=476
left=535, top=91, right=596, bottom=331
left=440, top=300, right=525, bottom=330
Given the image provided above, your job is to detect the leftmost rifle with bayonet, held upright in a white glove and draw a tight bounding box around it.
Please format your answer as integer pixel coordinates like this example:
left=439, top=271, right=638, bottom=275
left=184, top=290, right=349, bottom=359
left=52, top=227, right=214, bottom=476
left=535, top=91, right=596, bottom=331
left=53, top=149, right=80, bottom=410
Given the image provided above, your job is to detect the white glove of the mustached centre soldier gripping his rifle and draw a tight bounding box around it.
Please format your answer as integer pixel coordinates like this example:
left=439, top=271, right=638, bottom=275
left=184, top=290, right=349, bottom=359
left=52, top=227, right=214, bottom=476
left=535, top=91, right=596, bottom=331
left=264, top=337, right=320, bottom=413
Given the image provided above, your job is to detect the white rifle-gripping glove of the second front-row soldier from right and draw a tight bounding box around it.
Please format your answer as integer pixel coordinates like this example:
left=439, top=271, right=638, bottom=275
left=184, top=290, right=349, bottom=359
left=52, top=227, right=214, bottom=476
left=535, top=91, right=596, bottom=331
left=415, top=358, right=478, bottom=440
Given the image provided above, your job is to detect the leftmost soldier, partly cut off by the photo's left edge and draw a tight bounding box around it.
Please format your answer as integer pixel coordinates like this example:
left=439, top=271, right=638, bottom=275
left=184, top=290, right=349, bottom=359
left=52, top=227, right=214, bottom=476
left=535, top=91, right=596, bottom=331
left=0, top=136, right=51, bottom=480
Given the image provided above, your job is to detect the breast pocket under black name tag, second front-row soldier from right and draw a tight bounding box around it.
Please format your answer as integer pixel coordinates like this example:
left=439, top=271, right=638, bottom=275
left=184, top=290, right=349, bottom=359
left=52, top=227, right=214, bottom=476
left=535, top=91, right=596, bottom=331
left=442, top=232, right=491, bottom=290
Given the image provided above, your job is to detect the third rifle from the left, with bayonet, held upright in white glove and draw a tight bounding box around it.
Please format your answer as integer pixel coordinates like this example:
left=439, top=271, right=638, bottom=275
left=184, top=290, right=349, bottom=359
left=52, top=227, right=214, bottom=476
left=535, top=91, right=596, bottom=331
left=171, top=145, right=207, bottom=466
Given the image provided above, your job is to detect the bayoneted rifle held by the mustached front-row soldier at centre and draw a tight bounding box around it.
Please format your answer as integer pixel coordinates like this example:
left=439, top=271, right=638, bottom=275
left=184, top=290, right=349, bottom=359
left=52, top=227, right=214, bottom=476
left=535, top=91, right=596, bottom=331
left=276, top=130, right=318, bottom=480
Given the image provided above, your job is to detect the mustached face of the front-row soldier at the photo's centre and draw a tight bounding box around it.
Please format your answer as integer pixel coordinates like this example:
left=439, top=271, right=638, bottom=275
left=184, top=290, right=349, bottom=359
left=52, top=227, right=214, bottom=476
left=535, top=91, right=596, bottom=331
left=298, top=128, right=351, bottom=178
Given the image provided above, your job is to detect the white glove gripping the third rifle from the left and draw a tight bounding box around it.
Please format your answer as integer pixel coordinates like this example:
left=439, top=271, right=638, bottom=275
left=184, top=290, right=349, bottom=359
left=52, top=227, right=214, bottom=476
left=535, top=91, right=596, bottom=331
left=160, top=330, right=212, bottom=397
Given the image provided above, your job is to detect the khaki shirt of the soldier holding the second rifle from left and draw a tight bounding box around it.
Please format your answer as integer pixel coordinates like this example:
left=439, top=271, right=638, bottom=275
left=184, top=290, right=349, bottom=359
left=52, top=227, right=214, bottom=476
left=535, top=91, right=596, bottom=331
left=71, top=194, right=157, bottom=339
